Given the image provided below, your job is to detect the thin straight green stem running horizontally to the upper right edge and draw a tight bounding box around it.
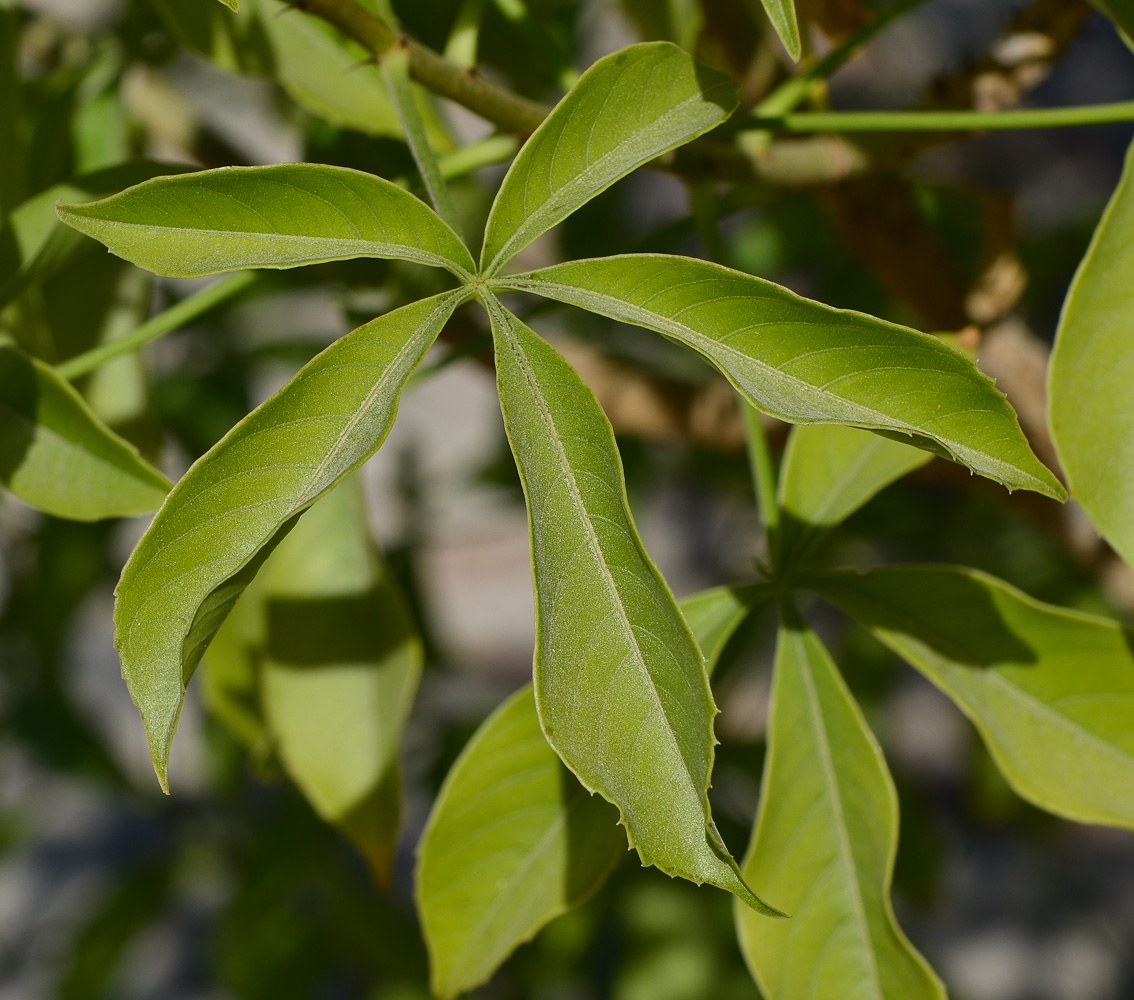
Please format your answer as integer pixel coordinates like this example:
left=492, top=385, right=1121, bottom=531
left=748, top=101, right=1134, bottom=133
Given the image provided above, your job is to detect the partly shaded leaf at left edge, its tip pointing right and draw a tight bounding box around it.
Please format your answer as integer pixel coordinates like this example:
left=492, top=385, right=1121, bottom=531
left=0, top=345, right=170, bottom=520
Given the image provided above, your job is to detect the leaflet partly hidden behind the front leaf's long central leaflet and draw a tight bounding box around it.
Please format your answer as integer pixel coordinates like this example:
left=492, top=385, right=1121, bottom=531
left=416, top=584, right=768, bottom=997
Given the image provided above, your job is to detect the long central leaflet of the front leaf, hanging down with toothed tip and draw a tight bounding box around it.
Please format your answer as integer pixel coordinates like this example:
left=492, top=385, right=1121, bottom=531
left=486, top=296, right=776, bottom=914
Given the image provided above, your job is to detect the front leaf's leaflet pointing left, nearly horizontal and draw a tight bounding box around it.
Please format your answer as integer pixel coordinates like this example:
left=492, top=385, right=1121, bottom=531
left=58, top=163, right=474, bottom=280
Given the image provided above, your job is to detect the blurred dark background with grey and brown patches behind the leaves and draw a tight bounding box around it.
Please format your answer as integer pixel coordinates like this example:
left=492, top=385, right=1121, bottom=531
left=0, top=0, right=1134, bottom=1000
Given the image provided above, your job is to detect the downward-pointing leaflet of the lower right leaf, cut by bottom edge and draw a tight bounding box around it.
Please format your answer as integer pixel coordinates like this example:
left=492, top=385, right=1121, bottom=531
left=736, top=612, right=945, bottom=1000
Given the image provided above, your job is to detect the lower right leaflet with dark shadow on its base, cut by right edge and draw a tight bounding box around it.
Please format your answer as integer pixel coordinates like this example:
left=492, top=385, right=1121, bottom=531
left=809, top=566, right=1134, bottom=829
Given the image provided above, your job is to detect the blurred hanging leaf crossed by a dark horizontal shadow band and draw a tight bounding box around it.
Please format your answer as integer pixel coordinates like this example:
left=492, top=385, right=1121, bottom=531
left=260, top=477, right=422, bottom=885
